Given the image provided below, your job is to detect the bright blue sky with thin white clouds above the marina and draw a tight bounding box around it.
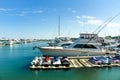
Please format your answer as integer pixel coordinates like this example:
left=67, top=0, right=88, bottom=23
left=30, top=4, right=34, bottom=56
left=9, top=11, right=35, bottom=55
left=0, top=0, right=120, bottom=39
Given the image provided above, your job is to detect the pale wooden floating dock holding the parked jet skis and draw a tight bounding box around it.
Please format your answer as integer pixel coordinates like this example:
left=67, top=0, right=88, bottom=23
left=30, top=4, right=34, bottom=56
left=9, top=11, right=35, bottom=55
left=30, top=58, right=120, bottom=69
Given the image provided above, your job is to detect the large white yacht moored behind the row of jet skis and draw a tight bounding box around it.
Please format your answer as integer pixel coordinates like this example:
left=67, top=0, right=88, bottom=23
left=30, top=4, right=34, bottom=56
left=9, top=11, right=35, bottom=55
left=39, top=33, right=116, bottom=56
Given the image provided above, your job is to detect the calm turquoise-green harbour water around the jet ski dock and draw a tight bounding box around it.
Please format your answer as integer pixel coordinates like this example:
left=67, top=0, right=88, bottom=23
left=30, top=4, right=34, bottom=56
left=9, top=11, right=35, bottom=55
left=0, top=42, right=120, bottom=80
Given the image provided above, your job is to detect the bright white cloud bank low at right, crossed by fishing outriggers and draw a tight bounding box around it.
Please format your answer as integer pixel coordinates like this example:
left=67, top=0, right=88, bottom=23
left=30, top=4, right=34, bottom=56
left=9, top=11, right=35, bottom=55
left=76, top=16, right=120, bottom=28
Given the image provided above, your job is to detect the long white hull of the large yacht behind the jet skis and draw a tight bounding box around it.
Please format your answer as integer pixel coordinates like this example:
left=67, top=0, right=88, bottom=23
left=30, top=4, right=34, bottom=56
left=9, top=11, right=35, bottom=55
left=39, top=47, right=112, bottom=56
